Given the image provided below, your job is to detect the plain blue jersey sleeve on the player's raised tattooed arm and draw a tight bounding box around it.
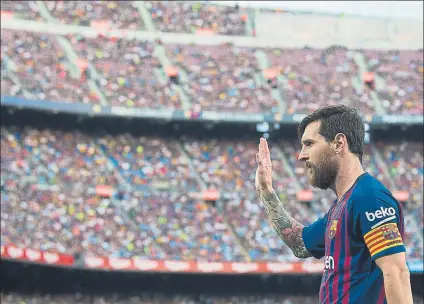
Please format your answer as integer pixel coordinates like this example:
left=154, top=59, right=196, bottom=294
left=302, top=214, right=327, bottom=259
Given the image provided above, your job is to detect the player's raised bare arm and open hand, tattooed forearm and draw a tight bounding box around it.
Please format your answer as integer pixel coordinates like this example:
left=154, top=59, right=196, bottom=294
left=255, top=138, right=312, bottom=258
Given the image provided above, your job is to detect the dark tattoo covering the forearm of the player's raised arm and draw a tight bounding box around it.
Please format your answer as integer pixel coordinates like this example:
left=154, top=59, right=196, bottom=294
left=259, top=191, right=311, bottom=258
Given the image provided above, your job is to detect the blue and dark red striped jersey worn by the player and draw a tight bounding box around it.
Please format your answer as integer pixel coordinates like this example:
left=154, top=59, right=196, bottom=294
left=303, top=173, right=406, bottom=304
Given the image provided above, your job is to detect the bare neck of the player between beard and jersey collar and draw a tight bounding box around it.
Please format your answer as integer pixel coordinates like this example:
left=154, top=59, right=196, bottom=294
left=331, top=158, right=365, bottom=200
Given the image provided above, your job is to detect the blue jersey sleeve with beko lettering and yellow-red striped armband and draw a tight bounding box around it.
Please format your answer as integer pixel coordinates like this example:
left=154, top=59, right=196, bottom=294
left=353, top=191, right=406, bottom=260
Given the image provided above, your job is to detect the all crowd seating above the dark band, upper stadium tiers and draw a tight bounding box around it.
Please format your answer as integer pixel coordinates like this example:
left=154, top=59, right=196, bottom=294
left=1, top=1, right=423, bottom=115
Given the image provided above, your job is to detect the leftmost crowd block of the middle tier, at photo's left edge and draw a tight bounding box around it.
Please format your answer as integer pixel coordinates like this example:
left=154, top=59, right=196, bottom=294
left=1, top=29, right=99, bottom=104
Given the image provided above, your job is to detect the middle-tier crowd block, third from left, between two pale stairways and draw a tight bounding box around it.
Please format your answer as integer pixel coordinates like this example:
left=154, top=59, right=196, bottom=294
left=165, top=44, right=278, bottom=113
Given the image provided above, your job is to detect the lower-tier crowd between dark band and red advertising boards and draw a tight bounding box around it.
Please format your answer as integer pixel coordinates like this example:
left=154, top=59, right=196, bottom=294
left=1, top=127, right=423, bottom=261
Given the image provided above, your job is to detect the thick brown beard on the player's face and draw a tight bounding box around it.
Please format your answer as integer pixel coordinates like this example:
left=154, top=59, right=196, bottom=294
left=306, top=152, right=339, bottom=190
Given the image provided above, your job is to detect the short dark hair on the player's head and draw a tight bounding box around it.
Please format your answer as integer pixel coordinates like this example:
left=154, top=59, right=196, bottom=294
left=297, top=105, right=365, bottom=162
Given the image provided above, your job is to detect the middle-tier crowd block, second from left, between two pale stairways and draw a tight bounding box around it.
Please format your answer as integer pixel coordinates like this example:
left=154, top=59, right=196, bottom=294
left=67, top=35, right=181, bottom=109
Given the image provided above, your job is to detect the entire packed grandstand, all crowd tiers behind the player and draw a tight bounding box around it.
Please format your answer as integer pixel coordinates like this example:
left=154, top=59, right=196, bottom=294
left=1, top=1, right=423, bottom=304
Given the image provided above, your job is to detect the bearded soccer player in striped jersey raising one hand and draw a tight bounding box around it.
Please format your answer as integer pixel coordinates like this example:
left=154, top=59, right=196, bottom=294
left=255, top=105, right=413, bottom=304
